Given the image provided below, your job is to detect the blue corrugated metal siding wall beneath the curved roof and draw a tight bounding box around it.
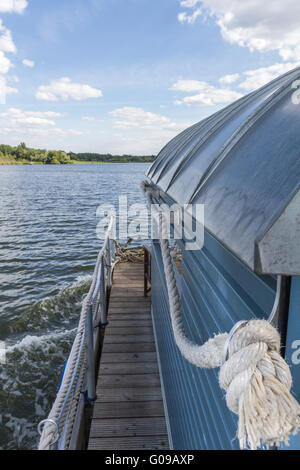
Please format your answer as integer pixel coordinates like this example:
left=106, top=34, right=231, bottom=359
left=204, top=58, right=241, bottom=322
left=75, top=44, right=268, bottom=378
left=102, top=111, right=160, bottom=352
left=152, top=233, right=276, bottom=450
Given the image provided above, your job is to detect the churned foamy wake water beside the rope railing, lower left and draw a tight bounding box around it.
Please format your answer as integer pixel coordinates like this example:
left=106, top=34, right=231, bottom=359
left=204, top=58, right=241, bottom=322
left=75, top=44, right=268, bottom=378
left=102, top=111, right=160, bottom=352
left=0, top=276, right=92, bottom=449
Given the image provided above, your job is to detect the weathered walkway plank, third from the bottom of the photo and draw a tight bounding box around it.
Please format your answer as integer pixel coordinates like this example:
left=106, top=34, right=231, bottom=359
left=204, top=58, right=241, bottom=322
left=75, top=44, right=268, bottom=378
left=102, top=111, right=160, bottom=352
left=94, top=401, right=165, bottom=419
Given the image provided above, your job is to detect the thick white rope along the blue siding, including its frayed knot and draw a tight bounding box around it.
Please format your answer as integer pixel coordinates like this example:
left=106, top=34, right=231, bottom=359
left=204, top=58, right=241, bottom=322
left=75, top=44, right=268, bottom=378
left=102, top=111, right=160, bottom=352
left=142, top=182, right=300, bottom=449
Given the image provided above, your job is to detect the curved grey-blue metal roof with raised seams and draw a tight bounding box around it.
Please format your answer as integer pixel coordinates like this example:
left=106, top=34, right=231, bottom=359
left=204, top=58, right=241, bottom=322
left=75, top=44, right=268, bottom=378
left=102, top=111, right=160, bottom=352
left=147, top=67, right=300, bottom=275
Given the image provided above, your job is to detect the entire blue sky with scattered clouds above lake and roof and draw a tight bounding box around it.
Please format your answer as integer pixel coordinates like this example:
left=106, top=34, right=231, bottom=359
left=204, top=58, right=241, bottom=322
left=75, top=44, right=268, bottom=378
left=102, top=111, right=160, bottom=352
left=0, top=0, right=300, bottom=155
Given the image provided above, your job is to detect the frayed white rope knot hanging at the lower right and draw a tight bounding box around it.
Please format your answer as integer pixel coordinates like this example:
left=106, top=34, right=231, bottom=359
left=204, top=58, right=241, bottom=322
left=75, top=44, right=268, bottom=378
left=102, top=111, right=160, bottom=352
left=219, top=320, right=300, bottom=449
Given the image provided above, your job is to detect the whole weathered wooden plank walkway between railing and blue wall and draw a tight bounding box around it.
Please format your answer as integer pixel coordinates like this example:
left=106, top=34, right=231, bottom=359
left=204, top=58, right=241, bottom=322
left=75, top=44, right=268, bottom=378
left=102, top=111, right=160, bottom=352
left=88, top=263, right=169, bottom=450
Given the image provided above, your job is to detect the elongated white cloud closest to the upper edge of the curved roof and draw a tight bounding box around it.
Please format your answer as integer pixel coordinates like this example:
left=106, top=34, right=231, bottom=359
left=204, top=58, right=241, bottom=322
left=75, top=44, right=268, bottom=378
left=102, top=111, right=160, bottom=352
left=171, top=80, right=243, bottom=106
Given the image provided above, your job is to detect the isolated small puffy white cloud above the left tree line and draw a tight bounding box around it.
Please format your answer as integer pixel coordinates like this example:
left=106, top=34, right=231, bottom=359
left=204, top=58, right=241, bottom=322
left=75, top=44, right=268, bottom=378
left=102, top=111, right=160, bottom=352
left=36, top=77, right=102, bottom=101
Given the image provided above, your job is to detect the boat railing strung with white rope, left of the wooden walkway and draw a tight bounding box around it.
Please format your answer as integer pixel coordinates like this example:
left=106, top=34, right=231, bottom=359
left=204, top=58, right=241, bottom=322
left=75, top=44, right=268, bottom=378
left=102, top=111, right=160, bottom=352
left=38, top=217, right=115, bottom=450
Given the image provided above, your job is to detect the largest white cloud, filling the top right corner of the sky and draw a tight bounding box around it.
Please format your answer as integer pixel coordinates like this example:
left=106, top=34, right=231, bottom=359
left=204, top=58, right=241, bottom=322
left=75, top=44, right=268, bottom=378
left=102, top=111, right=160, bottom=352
left=178, top=0, right=300, bottom=60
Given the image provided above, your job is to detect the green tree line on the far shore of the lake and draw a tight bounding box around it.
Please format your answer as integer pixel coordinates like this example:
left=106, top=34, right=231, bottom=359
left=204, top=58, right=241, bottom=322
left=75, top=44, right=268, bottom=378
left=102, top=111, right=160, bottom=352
left=0, top=142, right=155, bottom=165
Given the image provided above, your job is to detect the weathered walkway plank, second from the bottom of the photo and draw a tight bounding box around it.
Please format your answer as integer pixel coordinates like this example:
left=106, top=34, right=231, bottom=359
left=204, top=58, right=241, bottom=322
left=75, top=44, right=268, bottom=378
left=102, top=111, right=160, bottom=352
left=90, top=417, right=167, bottom=438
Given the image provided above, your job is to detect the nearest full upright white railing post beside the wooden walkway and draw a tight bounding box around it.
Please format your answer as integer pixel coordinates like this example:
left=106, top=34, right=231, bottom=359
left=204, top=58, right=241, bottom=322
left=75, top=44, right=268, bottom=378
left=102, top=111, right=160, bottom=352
left=86, top=304, right=97, bottom=402
